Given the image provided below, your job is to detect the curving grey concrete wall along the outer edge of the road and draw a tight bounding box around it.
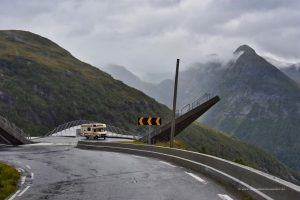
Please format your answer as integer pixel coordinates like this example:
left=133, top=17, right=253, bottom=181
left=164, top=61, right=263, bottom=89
left=78, top=141, right=300, bottom=200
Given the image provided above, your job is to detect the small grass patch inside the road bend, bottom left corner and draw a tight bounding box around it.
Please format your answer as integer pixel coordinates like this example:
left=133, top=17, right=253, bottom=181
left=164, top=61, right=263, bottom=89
left=0, top=162, right=20, bottom=200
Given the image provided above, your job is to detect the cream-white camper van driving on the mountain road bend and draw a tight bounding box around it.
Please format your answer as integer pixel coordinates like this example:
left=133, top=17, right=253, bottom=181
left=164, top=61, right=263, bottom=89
left=80, top=123, right=107, bottom=139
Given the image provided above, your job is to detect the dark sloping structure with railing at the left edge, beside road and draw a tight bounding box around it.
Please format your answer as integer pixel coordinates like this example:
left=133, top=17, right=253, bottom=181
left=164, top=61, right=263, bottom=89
left=0, top=116, right=31, bottom=145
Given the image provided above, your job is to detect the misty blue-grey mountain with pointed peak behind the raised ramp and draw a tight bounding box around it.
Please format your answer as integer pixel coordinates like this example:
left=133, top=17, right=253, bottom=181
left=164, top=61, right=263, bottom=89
left=108, top=45, right=300, bottom=170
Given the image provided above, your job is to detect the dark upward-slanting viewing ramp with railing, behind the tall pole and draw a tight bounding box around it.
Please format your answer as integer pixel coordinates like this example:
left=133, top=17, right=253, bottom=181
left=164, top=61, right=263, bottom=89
left=139, top=95, right=220, bottom=144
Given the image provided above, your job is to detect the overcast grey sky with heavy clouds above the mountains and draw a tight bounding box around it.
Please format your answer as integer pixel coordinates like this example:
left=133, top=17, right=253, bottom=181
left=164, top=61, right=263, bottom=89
left=0, top=0, right=300, bottom=80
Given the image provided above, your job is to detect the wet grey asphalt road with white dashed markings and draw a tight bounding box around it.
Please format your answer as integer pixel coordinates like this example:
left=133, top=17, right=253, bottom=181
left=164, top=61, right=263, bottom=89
left=0, top=139, right=241, bottom=200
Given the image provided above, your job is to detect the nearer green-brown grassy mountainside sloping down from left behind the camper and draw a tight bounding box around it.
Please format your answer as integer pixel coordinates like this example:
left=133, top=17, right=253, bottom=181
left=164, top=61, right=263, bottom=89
left=0, top=31, right=300, bottom=184
